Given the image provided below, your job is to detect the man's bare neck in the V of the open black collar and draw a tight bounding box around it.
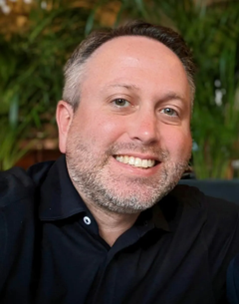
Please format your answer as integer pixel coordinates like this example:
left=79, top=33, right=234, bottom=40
left=85, top=201, right=140, bottom=246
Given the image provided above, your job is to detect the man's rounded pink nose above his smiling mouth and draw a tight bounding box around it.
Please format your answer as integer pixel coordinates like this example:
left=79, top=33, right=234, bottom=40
left=128, top=110, right=158, bottom=144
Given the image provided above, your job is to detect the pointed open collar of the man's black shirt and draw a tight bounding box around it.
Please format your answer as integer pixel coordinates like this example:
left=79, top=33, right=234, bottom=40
left=39, top=155, right=177, bottom=231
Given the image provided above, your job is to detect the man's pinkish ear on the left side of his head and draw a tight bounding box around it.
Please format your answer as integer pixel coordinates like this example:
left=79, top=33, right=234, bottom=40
left=56, top=100, right=74, bottom=153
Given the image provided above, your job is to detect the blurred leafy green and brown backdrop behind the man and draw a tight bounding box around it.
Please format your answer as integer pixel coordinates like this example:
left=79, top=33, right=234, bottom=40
left=0, top=0, right=239, bottom=179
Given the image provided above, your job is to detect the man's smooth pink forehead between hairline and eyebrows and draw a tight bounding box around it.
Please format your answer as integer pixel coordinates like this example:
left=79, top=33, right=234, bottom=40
left=81, top=36, right=189, bottom=100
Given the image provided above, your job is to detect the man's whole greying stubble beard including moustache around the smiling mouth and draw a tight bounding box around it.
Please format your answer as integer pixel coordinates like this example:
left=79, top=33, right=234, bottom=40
left=66, top=134, right=190, bottom=214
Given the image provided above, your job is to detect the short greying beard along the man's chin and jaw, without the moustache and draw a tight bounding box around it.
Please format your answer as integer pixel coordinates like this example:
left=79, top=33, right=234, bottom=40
left=66, top=144, right=188, bottom=214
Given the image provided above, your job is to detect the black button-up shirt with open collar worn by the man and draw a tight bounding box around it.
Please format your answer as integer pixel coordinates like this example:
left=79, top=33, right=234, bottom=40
left=0, top=157, right=239, bottom=304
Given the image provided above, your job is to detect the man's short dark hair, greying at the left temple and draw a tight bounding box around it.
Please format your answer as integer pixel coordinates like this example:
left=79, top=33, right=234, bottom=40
left=63, top=21, right=195, bottom=110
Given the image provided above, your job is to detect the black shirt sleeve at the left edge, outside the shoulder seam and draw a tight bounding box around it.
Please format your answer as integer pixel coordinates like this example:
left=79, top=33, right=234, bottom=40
left=0, top=163, right=55, bottom=292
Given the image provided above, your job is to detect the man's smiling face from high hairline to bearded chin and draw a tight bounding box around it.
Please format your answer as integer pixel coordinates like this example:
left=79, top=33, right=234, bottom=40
left=58, top=36, right=191, bottom=213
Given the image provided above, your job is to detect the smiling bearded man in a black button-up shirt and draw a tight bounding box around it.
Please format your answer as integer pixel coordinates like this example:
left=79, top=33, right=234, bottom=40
left=0, top=22, right=239, bottom=304
